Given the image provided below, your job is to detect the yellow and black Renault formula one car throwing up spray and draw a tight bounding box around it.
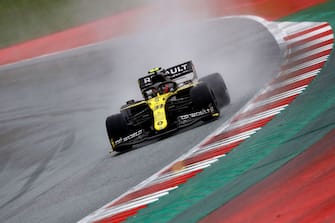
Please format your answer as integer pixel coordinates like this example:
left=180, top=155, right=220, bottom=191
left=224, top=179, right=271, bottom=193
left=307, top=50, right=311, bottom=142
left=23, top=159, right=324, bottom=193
left=106, top=61, right=230, bottom=151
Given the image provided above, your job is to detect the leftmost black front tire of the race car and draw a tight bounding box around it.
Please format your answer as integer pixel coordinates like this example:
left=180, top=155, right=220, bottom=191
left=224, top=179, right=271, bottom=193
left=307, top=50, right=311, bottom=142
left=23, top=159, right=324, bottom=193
left=106, top=113, right=131, bottom=151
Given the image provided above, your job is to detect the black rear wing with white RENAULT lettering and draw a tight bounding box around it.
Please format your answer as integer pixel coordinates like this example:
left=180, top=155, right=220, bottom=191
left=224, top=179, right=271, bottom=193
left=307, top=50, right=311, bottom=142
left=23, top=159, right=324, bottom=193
left=138, top=61, right=198, bottom=90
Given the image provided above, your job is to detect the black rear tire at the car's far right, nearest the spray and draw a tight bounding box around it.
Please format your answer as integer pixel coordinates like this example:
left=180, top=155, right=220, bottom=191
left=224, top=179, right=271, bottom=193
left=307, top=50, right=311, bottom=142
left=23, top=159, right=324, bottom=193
left=200, top=73, right=230, bottom=108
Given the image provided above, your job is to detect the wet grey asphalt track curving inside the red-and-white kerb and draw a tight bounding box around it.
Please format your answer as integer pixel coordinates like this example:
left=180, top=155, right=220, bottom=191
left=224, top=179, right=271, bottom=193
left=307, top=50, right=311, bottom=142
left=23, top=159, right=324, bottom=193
left=0, top=19, right=280, bottom=223
